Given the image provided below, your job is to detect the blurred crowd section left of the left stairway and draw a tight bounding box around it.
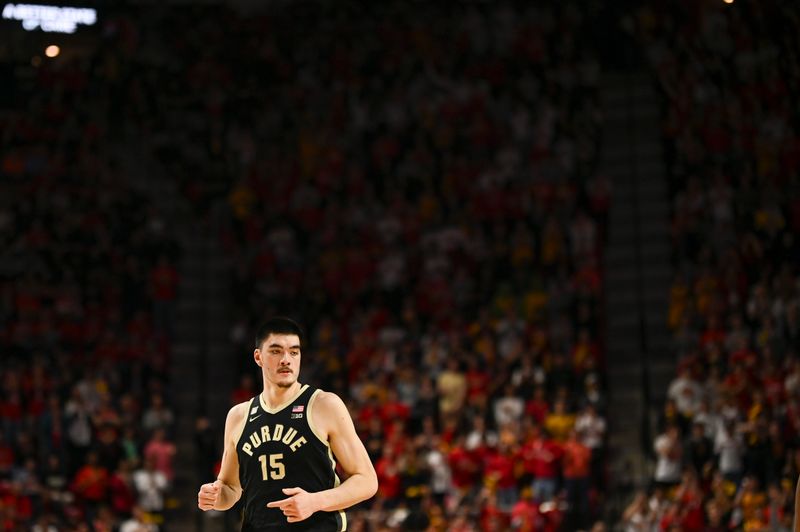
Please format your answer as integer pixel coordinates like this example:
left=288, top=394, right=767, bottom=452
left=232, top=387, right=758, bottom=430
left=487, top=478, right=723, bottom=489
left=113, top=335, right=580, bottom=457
left=0, top=26, right=179, bottom=532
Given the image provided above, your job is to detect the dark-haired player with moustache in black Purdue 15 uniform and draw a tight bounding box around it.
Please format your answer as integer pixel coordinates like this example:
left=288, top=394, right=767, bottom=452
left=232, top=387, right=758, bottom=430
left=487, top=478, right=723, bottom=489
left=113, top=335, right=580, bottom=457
left=197, top=318, right=378, bottom=532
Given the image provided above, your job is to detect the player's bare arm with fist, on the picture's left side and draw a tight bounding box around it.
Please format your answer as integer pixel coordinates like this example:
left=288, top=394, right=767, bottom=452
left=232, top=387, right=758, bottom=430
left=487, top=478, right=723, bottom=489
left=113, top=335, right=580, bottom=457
left=197, top=402, right=248, bottom=511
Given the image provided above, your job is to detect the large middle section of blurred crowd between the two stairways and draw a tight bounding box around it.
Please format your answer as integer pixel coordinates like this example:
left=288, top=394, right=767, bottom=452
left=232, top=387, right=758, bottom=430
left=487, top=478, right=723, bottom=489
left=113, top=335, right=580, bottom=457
left=169, top=2, right=609, bottom=531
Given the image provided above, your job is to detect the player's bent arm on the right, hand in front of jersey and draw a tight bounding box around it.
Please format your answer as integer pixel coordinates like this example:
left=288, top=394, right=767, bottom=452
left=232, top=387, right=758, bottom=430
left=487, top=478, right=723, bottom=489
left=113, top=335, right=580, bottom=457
left=267, top=392, right=378, bottom=523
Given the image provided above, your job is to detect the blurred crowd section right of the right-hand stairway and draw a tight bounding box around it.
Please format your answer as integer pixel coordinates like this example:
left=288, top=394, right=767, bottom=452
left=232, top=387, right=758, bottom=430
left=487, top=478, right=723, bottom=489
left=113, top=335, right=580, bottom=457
left=625, top=1, right=800, bottom=531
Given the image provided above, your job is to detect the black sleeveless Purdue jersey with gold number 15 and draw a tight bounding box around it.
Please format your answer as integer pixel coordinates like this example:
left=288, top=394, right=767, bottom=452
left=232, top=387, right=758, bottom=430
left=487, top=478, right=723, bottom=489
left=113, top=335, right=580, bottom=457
left=236, top=384, right=347, bottom=532
